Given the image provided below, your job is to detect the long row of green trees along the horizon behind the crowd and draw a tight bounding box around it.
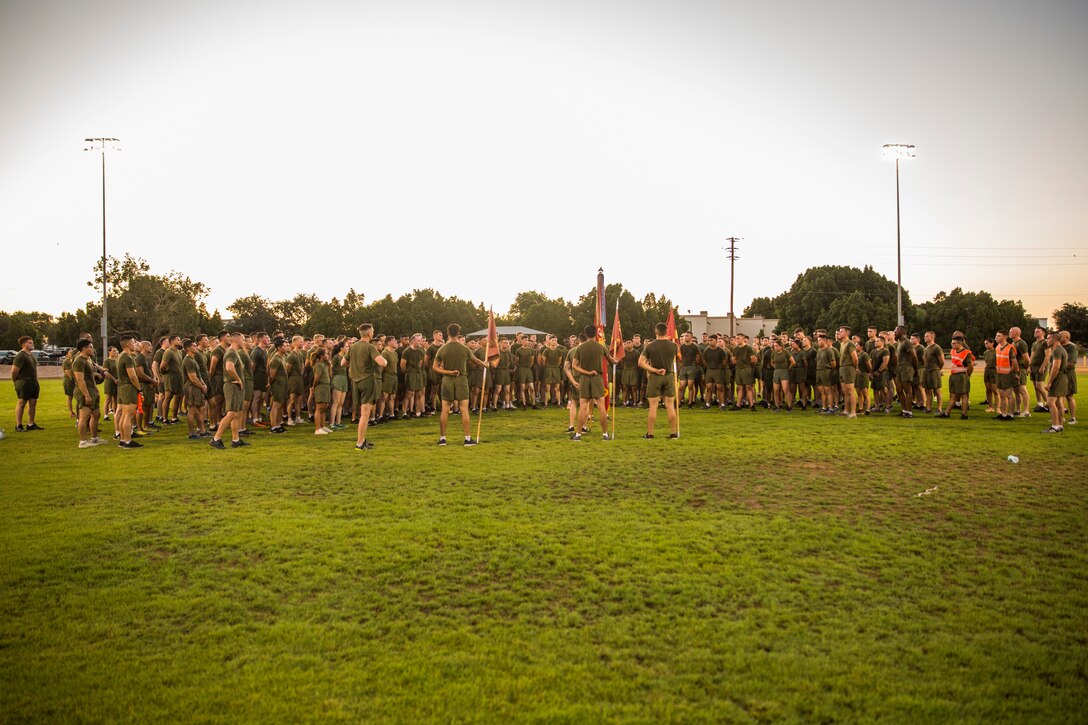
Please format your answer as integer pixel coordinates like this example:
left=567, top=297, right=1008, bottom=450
left=0, top=255, right=1088, bottom=349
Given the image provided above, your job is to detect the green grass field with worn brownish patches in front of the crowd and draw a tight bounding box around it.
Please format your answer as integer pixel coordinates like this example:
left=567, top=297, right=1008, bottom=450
left=0, top=374, right=1088, bottom=723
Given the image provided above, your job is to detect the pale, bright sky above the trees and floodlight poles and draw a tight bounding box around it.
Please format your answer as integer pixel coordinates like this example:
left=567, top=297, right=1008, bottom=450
left=0, top=0, right=1088, bottom=316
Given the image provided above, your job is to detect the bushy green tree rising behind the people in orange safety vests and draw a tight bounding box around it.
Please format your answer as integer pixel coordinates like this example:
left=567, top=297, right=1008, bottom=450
left=918, top=287, right=1034, bottom=352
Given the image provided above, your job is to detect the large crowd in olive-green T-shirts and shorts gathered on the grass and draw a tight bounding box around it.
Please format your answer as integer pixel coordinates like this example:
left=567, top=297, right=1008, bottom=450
left=11, top=323, right=1078, bottom=450
